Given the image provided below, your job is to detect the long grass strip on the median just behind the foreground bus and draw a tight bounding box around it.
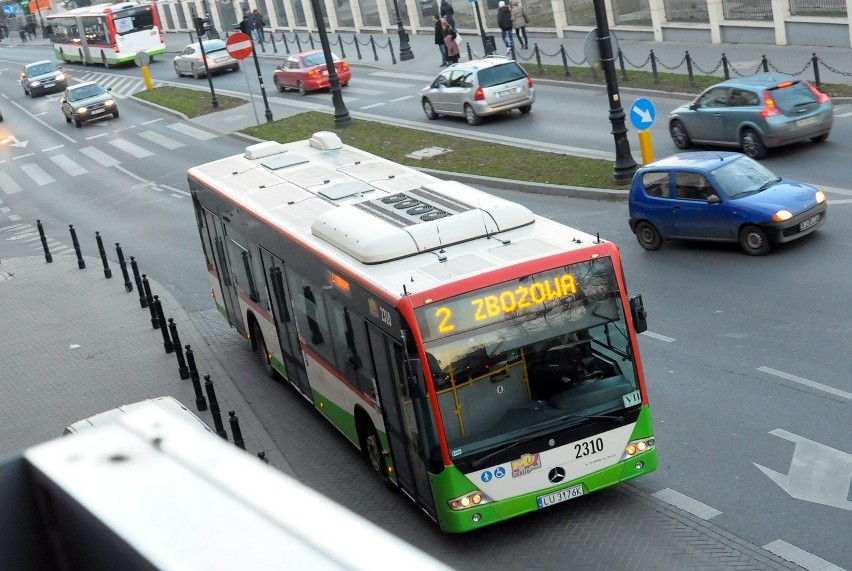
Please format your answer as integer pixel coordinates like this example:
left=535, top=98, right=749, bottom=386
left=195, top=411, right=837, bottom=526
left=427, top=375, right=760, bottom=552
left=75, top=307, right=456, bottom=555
left=242, top=112, right=626, bottom=188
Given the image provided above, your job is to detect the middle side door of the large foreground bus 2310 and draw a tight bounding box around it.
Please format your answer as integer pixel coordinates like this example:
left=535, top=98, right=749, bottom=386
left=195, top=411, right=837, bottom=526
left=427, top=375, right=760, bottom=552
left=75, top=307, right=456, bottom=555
left=260, top=248, right=312, bottom=400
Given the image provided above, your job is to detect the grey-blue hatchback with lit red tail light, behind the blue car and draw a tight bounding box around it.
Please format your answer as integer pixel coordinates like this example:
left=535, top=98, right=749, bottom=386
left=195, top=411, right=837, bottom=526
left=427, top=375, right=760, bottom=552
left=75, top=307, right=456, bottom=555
left=668, top=73, right=834, bottom=159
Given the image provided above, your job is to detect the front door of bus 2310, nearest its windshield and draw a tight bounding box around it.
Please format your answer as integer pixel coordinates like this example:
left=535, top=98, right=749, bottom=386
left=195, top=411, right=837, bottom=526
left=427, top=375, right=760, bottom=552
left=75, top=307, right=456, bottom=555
left=367, top=323, right=435, bottom=518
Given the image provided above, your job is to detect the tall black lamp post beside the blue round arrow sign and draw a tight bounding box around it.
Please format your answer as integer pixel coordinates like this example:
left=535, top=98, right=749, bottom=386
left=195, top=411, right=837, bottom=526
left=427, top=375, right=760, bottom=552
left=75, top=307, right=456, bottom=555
left=593, top=0, right=637, bottom=184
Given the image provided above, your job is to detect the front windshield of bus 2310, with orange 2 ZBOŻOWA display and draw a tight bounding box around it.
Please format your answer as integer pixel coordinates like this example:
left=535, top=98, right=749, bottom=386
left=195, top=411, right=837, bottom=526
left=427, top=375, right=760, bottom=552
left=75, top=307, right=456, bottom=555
left=418, top=258, right=642, bottom=460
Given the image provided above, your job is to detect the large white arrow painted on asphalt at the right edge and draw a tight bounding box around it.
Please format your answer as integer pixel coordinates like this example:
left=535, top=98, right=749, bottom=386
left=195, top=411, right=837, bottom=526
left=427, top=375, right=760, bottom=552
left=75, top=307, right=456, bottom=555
left=752, top=428, right=852, bottom=511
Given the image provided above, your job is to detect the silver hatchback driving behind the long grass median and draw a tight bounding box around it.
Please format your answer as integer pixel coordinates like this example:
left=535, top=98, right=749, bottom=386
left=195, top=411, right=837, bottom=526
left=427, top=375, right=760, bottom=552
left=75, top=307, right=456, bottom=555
left=420, top=56, right=535, bottom=125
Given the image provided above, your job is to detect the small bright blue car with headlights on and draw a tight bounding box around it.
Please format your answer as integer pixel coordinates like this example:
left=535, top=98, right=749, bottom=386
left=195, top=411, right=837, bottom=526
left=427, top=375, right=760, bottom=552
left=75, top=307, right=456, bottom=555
left=628, top=151, right=828, bottom=256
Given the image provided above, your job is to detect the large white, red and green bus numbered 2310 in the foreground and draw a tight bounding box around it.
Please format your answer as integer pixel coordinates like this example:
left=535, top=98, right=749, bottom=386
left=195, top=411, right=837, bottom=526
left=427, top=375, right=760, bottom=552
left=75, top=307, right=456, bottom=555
left=188, top=131, right=657, bottom=532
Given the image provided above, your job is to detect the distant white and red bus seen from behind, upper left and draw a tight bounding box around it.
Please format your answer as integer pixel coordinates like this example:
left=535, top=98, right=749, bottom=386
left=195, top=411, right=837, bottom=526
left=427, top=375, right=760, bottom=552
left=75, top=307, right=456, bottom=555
left=46, top=2, right=166, bottom=66
